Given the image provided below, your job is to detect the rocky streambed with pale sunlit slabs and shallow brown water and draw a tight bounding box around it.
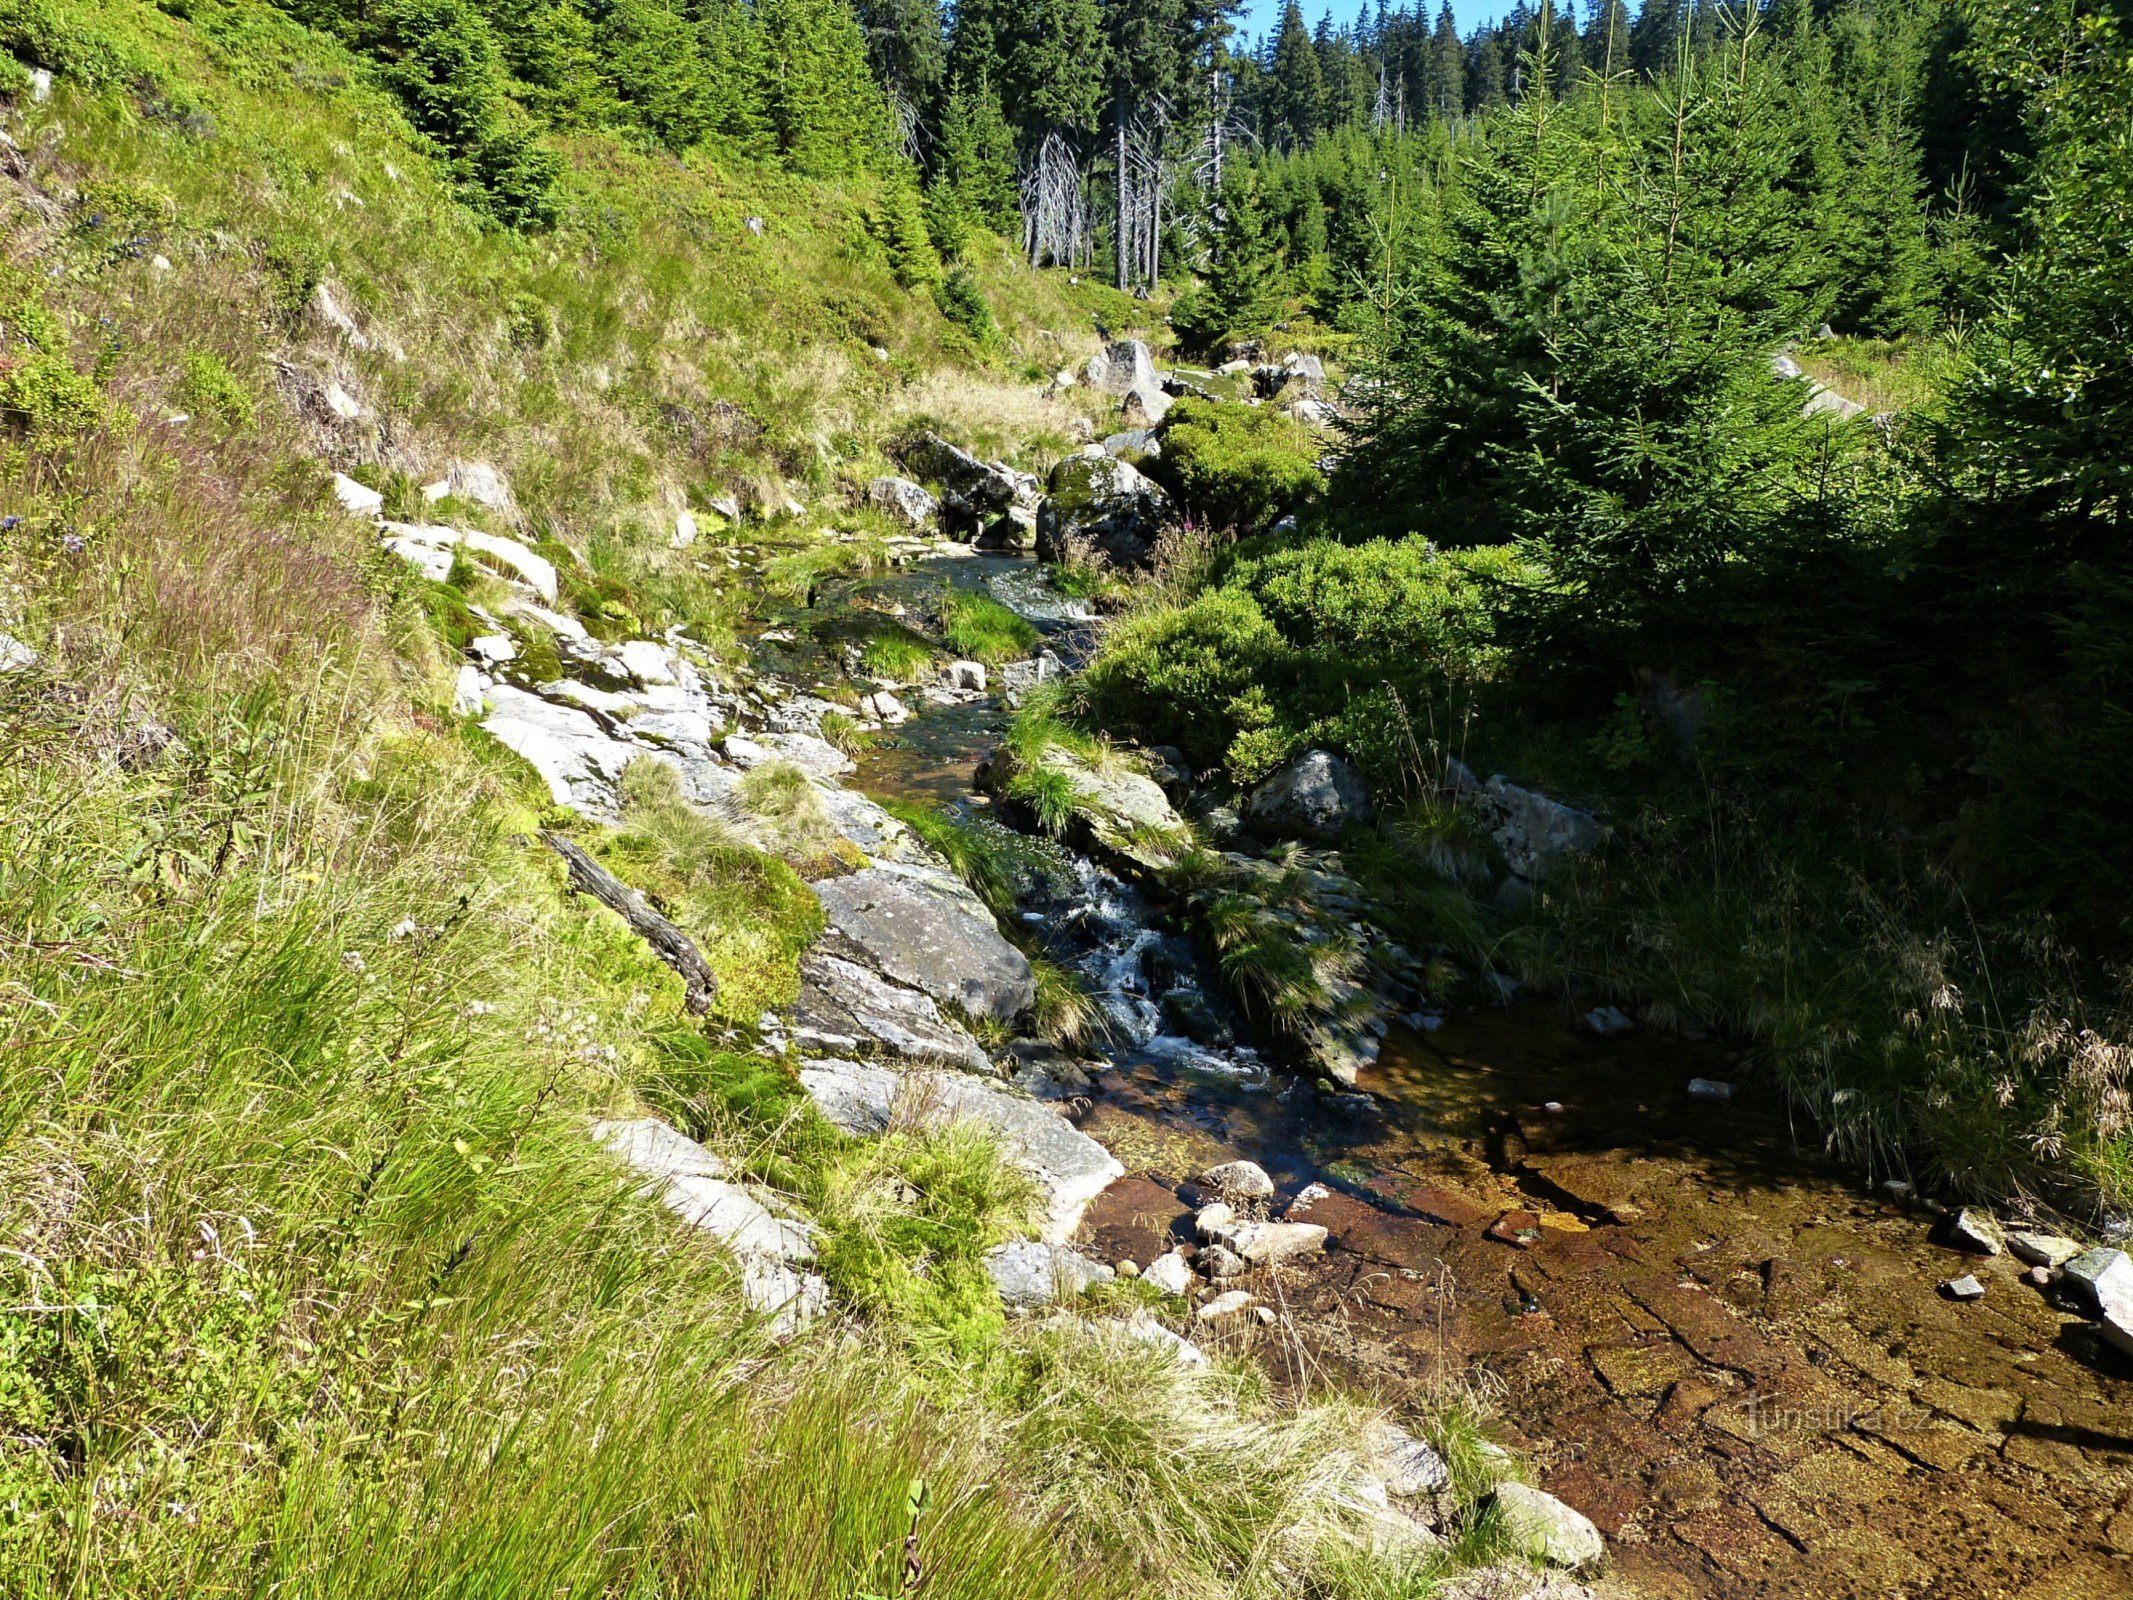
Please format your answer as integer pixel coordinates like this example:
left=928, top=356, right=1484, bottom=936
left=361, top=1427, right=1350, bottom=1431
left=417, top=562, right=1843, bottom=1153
left=371, top=480, right=2133, bottom=1600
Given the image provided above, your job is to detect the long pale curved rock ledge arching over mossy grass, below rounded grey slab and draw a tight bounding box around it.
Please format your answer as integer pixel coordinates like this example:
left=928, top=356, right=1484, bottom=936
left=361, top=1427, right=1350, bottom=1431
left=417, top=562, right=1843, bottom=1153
left=800, top=1060, right=1126, bottom=1244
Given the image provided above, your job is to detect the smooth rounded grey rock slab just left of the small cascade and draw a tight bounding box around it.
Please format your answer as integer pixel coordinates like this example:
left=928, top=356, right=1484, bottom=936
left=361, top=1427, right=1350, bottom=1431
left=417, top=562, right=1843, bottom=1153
left=813, top=866, right=1037, bottom=1022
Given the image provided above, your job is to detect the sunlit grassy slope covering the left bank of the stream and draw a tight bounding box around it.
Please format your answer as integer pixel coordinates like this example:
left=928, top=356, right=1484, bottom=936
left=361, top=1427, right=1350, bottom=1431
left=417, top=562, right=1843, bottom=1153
left=0, top=0, right=1501, bottom=1596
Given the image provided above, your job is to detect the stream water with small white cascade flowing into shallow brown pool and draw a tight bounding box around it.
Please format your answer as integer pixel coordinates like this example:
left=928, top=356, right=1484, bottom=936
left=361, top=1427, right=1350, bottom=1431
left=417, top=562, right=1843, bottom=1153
left=789, top=559, right=2133, bottom=1600
